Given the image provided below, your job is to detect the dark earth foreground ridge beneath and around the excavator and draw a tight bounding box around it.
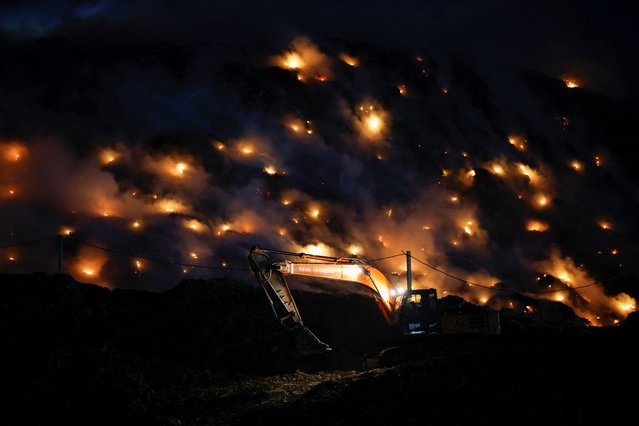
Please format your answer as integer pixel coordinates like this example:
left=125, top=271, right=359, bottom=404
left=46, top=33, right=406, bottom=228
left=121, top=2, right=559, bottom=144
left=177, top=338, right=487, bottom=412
left=0, top=274, right=639, bottom=425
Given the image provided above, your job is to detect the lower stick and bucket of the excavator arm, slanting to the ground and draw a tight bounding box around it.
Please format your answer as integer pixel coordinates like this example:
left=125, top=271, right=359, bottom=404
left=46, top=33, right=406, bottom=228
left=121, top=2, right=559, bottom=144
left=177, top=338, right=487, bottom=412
left=249, top=248, right=331, bottom=355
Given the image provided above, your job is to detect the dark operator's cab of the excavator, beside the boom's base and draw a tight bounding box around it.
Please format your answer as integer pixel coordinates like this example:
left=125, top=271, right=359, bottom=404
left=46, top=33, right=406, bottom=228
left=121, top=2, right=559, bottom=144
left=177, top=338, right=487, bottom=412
left=396, top=288, right=441, bottom=336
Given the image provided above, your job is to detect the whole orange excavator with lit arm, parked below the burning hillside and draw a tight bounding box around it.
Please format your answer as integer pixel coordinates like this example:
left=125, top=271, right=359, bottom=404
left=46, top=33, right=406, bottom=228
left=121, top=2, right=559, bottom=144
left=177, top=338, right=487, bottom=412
left=248, top=247, right=500, bottom=355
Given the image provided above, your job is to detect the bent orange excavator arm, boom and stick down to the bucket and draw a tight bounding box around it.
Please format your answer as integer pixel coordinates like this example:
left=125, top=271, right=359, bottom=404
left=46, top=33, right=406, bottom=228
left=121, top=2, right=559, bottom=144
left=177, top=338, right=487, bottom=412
left=248, top=247, right=393, bottom=354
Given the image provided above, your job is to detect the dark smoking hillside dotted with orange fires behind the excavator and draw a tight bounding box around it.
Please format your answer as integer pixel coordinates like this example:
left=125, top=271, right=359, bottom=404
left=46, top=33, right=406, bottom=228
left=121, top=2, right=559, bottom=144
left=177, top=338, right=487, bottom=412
left=0, top=29, right=637, bottom=325
